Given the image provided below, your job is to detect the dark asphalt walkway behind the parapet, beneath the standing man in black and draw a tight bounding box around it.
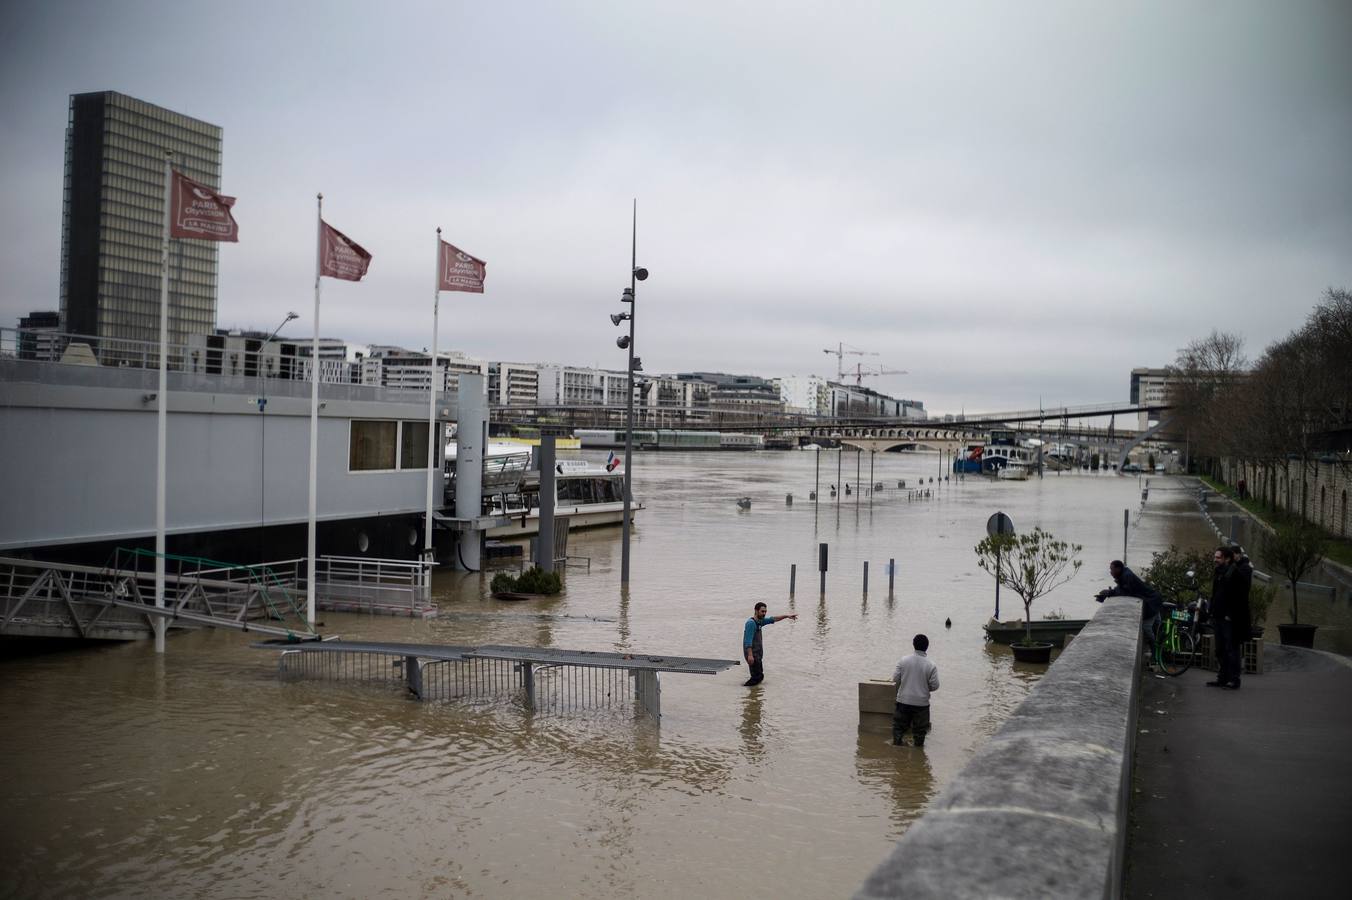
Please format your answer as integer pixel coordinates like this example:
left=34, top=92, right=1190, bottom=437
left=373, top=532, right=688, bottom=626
left=1126, top=646, right=1352, bottom=900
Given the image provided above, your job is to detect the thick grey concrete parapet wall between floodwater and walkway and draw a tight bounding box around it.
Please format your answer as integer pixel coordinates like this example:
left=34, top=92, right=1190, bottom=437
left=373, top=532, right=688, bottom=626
left=854, top=597, right=1141, bottom=900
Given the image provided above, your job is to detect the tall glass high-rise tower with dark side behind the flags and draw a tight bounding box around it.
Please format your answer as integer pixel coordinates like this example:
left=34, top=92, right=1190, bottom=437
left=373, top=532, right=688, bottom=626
left=61, top=91, right=220, bottom=345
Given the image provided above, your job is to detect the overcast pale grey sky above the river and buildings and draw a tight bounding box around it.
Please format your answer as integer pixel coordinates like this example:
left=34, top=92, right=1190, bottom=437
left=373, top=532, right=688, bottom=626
left=0, top=0, right=1352, bottom=412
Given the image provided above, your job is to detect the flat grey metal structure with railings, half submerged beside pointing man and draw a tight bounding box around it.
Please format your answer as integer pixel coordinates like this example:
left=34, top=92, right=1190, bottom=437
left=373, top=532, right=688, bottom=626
left=251, top=641, right=740, bottom=720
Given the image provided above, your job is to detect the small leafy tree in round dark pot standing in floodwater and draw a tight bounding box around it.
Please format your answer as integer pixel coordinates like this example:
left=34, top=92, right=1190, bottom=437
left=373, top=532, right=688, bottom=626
left=976, top=526, right=1083, bottom=662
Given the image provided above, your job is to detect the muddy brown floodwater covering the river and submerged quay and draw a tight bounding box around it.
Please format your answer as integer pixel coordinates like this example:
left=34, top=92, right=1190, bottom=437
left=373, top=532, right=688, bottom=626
left=0, top=450, right=1213, bottom=897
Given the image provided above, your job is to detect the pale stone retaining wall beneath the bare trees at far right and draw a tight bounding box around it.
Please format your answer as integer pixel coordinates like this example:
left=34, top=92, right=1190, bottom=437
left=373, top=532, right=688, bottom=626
left=1221, top=458, right=1352, bottom=538
